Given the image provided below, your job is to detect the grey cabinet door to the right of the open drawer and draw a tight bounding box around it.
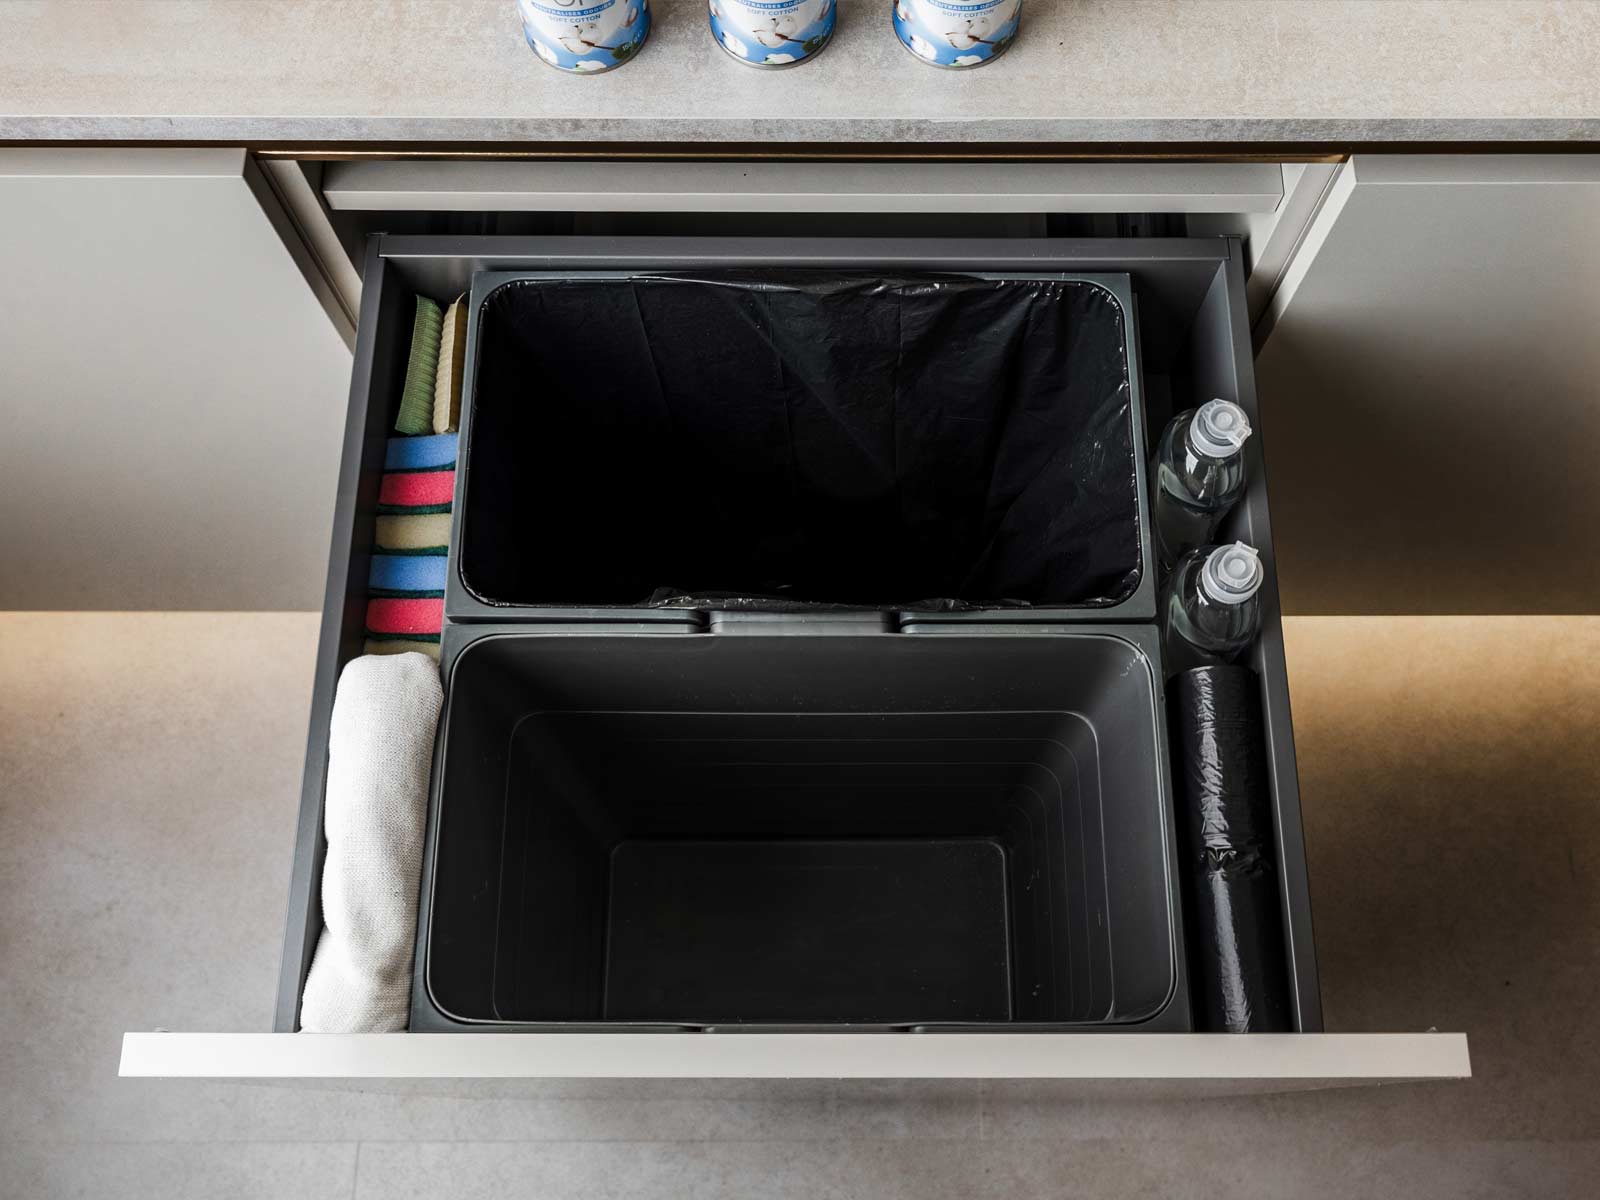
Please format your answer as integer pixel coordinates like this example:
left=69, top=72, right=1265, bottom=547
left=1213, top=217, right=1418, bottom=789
left=1256, top=155, right=1600, bottom=613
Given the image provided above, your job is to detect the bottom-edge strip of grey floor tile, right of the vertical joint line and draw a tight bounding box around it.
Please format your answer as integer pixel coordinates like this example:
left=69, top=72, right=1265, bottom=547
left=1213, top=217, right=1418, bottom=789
left=355, top=1131, right=1600, bottom=1200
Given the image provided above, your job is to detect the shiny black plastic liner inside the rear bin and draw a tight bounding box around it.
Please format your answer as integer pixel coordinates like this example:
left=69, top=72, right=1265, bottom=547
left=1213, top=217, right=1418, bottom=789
left=461, top=270, right=1141, bottom=610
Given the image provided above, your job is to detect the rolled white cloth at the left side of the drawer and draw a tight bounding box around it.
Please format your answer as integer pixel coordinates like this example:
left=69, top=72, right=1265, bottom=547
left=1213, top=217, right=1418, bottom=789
left=301, top=653, right=443, bottom=1034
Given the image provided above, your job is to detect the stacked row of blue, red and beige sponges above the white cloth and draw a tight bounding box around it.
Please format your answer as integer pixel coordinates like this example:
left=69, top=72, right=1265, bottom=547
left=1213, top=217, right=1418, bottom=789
left=366, top=432, right=456, bottom=659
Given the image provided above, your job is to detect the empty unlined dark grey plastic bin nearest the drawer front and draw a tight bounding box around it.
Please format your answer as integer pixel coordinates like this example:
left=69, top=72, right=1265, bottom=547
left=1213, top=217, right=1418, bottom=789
left=413, top=627, right=1189, bottom=1029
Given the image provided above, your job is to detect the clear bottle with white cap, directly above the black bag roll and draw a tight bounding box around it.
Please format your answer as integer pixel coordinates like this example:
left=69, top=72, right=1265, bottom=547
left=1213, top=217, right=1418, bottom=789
left=1158, top=542, right=1266, bottom=675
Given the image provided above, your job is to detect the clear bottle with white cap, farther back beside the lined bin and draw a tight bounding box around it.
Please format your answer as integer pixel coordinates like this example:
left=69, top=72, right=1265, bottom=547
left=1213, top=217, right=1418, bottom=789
left=1150, top=400, right=1250, bottom=571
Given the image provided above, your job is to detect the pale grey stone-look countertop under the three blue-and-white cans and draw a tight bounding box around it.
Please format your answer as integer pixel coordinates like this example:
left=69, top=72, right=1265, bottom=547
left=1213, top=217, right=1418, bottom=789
left=0, top=0, right=1600, bottom=150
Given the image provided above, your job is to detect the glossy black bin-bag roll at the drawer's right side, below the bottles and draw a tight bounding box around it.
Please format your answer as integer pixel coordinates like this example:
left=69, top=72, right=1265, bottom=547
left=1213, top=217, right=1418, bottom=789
left=1168, top=666, right=1294, bottom=1034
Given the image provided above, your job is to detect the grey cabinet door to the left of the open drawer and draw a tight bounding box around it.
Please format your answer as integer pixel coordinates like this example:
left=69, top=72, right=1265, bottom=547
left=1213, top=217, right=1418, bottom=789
left=0, top=149, right=350, bottom=610
